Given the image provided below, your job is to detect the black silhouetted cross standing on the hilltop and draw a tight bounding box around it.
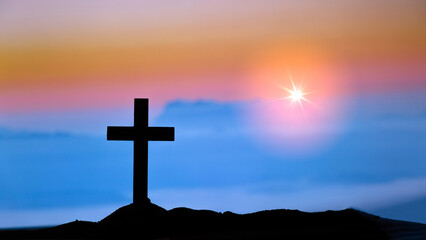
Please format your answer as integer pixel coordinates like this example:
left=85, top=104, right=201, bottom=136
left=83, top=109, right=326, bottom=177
left=107, top=98, right=175, bottom=205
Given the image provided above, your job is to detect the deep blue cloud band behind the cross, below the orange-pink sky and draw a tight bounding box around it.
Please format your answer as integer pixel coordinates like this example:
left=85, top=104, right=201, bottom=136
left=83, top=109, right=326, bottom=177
left=0, top=93, right=426, bottom=226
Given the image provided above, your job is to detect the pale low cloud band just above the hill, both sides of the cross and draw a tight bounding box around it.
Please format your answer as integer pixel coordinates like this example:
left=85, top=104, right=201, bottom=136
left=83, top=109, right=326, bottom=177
left=0, top=178, right=426, bottom=228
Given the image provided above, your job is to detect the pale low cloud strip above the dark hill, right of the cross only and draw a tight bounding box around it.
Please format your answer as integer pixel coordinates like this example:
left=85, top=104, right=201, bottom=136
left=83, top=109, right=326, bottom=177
left=150, top=178, right=426, bottom=213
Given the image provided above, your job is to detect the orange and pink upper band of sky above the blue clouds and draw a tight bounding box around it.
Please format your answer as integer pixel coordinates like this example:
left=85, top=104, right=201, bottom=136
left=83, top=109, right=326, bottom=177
left=0, top=0, right=426, bottom=112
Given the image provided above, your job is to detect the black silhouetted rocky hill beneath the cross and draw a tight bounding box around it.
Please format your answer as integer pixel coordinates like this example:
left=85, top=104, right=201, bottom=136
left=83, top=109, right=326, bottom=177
left=0, top=203, right=426, bottom=240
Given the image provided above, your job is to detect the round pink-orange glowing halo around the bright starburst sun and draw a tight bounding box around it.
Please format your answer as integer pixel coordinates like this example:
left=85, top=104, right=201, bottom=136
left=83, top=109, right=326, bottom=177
left=241, top=48, right=346, bottom=156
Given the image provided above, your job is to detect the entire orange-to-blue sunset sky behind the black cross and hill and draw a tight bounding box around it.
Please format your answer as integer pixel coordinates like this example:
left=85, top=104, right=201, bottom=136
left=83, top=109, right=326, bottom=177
left=0, top=0, right=426, bottom=227
